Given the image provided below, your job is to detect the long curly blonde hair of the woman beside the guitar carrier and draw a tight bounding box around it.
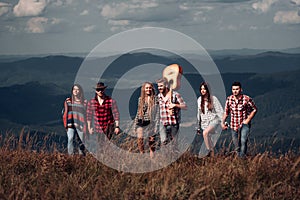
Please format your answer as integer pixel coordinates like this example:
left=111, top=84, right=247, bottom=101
left=138, top=82, right=156, bottom=119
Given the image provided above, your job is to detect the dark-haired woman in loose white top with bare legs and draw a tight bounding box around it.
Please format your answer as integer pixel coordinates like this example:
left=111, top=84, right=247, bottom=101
left=197, top=82, right=223, bottom=156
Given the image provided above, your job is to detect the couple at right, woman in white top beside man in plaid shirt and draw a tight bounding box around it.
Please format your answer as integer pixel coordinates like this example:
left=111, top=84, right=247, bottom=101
left=197, top=82, right=257, bottom=157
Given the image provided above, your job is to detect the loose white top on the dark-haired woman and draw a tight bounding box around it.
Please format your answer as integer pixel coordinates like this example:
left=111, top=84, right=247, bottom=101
left=197, top=96, right=224, bottom=130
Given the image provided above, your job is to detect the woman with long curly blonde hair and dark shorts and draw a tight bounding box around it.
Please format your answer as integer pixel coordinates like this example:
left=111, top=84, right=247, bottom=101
left=135, top=82, right=159, bottom=158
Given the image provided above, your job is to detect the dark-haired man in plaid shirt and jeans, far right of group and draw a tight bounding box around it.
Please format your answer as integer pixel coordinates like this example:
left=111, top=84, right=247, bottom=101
left=222, top=82, right=257, bottom=157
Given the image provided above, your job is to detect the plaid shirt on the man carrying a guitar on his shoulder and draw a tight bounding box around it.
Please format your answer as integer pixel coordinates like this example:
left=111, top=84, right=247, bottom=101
left=158, top=91, right=185, bottom=126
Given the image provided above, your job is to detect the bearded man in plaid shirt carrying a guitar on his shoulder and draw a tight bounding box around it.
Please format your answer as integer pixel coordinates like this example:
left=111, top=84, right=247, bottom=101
left=156, top=79, right=187, bottom=145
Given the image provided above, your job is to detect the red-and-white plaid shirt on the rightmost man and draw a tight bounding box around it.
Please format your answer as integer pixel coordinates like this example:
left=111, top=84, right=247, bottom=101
left=225, top=94, right=257, bottom=131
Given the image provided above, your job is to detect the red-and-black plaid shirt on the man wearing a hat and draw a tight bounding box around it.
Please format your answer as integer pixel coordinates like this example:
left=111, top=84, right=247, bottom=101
left=86, top=96, right=120, bottom=133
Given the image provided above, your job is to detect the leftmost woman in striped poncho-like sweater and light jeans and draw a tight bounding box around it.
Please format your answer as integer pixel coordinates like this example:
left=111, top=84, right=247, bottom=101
left=63, top=84, right=87, bottom=155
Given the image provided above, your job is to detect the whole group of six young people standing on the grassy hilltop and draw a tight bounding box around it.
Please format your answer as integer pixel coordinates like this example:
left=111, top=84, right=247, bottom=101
left=64, top=78, right=257, bottom=158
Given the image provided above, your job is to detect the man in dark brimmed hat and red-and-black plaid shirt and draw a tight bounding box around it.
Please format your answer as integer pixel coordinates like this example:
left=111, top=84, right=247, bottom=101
left=86, top=82, right=120, bottom=139
